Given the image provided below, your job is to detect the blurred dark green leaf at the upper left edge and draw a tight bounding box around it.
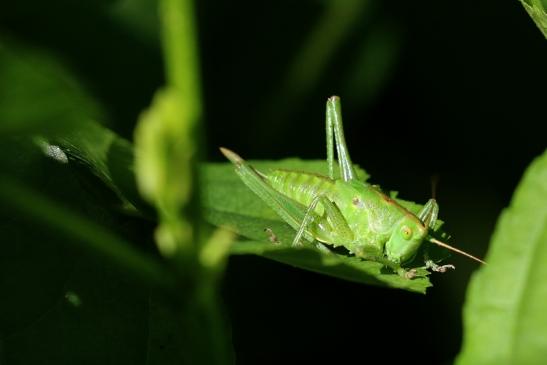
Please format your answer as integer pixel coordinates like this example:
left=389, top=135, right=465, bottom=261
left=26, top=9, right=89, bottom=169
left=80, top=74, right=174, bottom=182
left=0, top=38, right=101, bottom=135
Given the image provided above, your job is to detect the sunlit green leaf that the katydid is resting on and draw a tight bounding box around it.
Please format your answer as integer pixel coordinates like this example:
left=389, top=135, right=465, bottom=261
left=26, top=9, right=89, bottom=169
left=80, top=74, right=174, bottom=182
left=201, top=159, right=431, bottom=293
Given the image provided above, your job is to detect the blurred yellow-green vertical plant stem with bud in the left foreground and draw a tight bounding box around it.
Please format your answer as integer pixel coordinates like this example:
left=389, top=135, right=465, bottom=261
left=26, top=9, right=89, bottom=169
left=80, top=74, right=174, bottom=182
left=146, top=0, right=232, bottom=364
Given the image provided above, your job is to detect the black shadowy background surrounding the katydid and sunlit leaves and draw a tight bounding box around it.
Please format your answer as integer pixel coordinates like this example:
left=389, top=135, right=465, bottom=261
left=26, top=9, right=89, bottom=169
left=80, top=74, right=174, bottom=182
left=0, top=0, right=547, bottom=364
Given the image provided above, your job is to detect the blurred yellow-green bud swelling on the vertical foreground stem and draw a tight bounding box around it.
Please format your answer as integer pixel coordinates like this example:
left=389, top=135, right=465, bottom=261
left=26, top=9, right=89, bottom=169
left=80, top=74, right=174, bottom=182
left=135, top=89, right=199, bottom=256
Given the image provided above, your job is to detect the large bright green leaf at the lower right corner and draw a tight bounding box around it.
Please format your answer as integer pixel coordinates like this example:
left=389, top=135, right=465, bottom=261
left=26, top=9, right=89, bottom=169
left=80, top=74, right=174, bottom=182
left=458, top=151, right=547, bottom=365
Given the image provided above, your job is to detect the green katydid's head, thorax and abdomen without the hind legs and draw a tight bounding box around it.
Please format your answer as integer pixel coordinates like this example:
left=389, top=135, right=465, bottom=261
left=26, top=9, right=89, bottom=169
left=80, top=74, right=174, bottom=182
left=265, top=170, right=427, bottom=263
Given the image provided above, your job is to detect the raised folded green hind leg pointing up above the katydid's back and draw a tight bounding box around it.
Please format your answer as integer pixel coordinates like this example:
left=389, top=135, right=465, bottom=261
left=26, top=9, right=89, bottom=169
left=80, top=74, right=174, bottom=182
left=326, top=96, right=357, bottom=181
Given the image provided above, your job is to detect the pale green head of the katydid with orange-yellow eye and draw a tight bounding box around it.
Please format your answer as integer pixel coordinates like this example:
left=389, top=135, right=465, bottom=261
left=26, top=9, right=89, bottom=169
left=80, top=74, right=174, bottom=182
left=385, top=214, right=428, bottom=264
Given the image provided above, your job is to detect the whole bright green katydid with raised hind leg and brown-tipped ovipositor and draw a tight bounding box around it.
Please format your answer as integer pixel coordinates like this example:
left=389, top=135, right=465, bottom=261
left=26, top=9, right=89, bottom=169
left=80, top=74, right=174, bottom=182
left=220, top=96, right=484, bottom=278
